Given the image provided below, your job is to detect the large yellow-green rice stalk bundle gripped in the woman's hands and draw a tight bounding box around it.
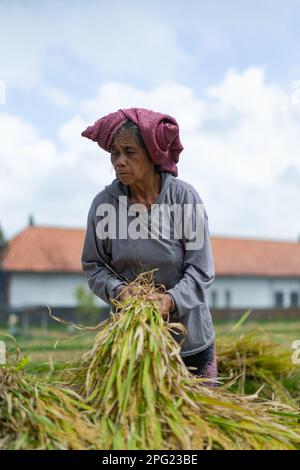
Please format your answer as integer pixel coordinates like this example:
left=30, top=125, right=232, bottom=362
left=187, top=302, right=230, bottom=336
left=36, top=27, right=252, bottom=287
left=59, top=276, right=300, bottom=450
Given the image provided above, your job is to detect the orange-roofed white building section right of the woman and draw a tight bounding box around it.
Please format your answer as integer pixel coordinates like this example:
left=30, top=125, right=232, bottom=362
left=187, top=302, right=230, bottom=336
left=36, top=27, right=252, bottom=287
left=208, top=237, right=300, bottom=309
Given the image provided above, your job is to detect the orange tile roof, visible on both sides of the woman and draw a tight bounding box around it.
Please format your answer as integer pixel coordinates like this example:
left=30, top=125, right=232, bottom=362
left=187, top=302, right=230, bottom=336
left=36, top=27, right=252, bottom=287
left=3, top=226, right=300, bottom=277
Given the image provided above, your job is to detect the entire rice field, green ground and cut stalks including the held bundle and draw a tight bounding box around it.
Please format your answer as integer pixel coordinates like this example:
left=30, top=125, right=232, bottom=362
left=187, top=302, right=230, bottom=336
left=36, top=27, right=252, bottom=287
left=0, top=277, right=300, bottom=450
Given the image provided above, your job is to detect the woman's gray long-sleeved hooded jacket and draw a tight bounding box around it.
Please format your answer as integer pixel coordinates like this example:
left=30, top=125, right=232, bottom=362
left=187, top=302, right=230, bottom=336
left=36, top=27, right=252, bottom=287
left=81, top=172, right=215, bottom=356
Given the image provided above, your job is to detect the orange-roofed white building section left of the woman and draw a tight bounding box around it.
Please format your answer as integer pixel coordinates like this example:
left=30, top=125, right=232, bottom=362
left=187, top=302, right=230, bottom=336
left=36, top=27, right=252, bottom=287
left=2, top=225, right=105, bottom=308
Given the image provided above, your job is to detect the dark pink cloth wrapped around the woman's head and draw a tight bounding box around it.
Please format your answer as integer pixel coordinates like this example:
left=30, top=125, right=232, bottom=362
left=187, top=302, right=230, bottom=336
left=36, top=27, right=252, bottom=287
left=81, top=108, right=183, bottom=176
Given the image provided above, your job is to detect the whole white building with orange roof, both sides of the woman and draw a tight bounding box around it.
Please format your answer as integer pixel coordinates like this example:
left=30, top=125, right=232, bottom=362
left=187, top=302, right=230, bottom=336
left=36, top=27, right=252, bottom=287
left=0, top=225, right=300, bottom=309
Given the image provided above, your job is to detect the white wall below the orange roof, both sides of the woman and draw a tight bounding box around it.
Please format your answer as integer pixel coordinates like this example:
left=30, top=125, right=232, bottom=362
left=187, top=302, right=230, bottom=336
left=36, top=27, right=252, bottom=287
left=9, top=273, right=300, bottom=309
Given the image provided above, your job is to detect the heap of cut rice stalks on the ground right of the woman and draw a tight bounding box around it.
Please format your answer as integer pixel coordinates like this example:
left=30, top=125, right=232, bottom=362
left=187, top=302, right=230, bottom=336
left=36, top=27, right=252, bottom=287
left=216, top=328, right=300, bottom=406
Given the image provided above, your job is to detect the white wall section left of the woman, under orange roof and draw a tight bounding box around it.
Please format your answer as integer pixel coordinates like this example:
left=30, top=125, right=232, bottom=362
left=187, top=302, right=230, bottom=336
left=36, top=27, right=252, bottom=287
left=9, top=273, right=106, bottom=307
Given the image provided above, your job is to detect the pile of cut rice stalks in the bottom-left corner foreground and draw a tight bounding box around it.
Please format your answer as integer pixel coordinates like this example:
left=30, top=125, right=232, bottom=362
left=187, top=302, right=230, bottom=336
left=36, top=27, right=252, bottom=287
left=0, top=361, right=98, bottom=450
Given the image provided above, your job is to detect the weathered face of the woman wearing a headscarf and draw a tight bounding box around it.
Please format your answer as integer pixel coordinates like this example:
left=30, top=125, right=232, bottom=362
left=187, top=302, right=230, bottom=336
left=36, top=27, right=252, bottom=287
left=110, top=129, right=154, bottom=185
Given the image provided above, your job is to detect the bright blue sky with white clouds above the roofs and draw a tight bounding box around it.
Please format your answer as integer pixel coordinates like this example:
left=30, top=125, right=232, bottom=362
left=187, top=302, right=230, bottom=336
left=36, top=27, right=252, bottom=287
left=0, top=0, right=300, bottom=241
